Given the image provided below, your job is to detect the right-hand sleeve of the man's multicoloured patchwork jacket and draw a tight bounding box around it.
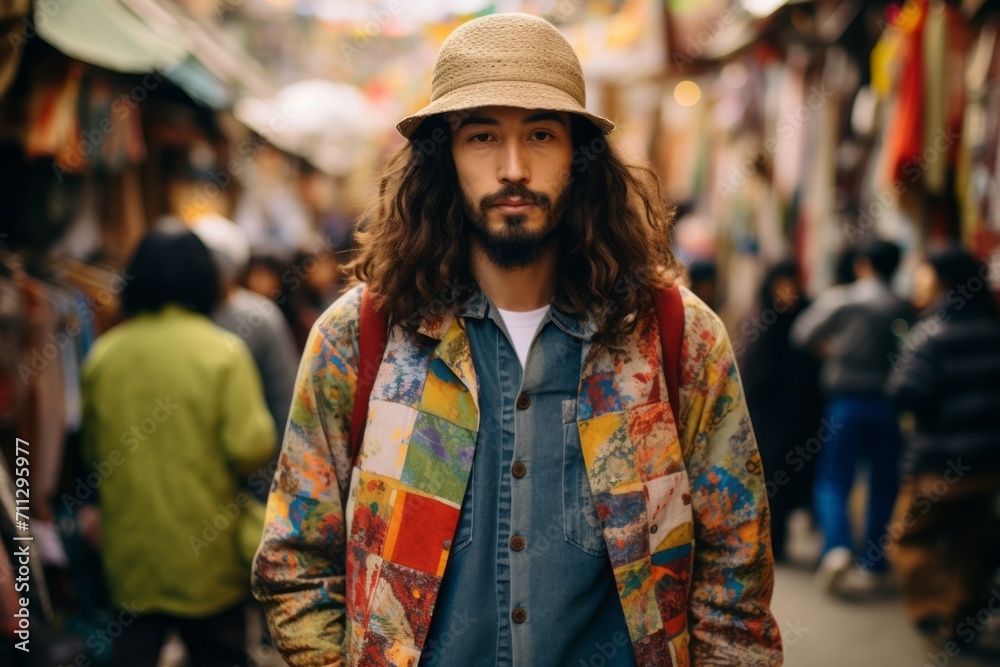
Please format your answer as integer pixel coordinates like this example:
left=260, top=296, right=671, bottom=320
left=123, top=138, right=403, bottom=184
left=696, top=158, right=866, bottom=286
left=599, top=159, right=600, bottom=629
left=680, top=297, right=783, bottom=667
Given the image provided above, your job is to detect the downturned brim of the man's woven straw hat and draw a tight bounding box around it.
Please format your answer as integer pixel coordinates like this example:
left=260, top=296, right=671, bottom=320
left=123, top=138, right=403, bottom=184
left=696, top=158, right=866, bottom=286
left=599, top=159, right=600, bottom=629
left=396, top=81, right=615, bottom=139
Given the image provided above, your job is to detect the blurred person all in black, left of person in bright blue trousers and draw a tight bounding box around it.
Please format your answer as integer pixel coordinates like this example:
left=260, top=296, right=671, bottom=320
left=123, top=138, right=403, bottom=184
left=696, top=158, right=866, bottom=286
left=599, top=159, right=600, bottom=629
left=740, top=260, right=823, bottom=559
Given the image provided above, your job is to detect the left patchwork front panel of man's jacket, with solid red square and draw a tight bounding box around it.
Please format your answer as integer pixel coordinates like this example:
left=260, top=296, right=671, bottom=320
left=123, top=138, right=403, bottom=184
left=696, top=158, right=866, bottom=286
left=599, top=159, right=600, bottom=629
left=348, top=316, right=479, bottom=665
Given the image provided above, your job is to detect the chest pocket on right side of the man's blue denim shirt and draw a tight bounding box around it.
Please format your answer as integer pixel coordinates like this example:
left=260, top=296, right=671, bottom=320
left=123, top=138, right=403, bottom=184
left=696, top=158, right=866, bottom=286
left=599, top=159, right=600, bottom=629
left=562, top=399, right=608, bottom=557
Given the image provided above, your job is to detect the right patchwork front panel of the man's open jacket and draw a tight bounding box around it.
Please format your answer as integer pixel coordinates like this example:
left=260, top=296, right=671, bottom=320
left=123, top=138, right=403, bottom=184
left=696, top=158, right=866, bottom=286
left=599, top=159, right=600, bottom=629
left=577, top=315, right=692, bottom=667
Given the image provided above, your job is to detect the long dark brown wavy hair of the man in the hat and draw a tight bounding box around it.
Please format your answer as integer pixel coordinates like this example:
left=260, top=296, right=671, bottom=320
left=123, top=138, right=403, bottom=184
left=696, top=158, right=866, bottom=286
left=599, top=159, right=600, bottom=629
left=347, top=115, right=682, bottom=342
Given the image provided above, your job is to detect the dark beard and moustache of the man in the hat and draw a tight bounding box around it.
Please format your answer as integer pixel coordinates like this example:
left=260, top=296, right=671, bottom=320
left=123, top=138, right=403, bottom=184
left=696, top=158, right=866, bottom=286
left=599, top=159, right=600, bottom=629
left=462, top=183, right=568, bottom=271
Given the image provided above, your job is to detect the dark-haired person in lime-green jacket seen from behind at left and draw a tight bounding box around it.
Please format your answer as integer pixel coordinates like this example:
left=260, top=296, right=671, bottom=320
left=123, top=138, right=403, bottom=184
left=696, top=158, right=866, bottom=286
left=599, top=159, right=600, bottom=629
left=82, top=231, right=276, bottom=667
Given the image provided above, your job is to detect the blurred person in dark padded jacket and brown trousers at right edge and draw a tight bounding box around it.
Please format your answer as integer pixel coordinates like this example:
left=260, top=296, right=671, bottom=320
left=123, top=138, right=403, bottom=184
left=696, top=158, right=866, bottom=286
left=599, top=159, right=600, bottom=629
left=886, top=248, right=1000, bottom=650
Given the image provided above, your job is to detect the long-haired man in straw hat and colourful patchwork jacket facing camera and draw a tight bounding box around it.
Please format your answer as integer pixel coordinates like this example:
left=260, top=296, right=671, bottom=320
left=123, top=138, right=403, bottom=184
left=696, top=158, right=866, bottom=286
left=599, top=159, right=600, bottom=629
left=253, top=14, right=782, bottom=667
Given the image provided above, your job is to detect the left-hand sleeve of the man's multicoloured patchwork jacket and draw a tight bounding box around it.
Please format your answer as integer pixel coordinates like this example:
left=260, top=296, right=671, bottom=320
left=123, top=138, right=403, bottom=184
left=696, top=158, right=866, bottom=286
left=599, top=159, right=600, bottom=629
left=252, top=289, right=360, bottom=667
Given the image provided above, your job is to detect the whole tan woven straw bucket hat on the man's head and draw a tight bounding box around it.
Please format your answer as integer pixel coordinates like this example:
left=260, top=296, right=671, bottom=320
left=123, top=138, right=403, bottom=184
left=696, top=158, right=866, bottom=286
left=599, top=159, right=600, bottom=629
left=396, top=14, right=615, bottom=138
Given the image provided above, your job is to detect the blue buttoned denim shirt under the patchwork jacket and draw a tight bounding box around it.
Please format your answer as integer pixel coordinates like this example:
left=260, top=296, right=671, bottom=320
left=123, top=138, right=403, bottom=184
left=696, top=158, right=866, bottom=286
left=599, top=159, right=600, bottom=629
left=420, top=295, right=636, bottom=667
